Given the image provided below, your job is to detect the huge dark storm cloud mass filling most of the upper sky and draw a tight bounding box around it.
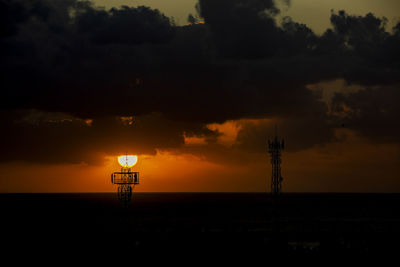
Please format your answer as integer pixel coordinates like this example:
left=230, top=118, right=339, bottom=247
left=0, top=0, right=400, bottom=164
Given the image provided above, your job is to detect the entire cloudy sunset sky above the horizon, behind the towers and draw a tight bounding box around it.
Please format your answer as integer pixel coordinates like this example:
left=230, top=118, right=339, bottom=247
left=0, top=0, right=400, bottom=193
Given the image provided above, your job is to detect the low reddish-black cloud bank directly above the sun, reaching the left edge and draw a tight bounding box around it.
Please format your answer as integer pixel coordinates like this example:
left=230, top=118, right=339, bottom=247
left=0, top=110, right=210, bottom=164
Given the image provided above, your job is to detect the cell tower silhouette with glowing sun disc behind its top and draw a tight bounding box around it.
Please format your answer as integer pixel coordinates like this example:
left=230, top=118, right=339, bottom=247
left=111, top=155, right=139, bottom=206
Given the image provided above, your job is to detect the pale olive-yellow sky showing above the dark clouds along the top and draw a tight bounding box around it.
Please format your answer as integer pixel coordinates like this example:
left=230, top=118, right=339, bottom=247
left=94, top=0, right=400, bottom=34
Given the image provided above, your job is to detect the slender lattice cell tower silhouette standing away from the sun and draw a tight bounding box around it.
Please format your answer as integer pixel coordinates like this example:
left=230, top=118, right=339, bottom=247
left=268, top=126, right=285, bottom=196
